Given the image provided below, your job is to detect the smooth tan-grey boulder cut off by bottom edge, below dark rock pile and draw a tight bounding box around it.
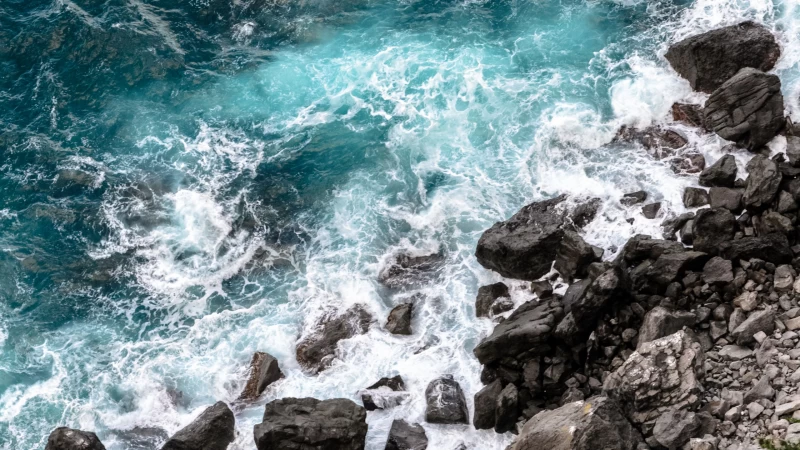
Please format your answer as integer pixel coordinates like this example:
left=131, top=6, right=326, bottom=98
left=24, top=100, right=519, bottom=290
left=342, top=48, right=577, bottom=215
left=509, top=397, right=644, bottom=450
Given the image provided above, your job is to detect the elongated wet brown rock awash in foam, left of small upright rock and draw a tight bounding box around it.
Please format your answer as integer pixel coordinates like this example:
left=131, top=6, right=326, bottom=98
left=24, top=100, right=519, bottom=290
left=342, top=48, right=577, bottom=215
left=296, top=305, right=372, bottom=373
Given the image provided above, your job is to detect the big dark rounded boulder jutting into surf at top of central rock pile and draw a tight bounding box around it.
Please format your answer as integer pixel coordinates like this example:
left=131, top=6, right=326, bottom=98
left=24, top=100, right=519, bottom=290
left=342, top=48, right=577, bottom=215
left=475, top=195, right=599, bottom=281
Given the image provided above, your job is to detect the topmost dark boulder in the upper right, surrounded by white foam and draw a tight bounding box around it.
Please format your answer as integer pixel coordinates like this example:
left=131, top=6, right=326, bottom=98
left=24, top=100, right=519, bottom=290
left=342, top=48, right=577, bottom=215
left=664, top=22, right=781, bottom=94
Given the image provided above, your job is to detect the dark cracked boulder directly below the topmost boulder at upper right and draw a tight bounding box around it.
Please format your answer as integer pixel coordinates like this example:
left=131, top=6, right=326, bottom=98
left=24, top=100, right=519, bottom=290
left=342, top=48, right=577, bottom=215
left=703, top=68, right=786, bottom=151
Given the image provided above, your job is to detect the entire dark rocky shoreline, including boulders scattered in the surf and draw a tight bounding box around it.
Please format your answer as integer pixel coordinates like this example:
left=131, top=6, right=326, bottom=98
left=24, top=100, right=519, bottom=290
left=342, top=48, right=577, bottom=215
left=46, top=22, right=800, bottom=450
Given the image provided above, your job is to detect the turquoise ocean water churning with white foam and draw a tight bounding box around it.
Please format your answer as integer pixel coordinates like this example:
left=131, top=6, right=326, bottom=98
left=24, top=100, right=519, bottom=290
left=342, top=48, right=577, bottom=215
left=0, top=0, right=800, bottom=450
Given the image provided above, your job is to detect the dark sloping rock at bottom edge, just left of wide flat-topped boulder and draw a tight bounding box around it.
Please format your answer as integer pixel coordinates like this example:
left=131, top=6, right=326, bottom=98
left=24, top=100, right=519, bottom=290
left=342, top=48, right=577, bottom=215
left=161, top=402, right=236, bottom=450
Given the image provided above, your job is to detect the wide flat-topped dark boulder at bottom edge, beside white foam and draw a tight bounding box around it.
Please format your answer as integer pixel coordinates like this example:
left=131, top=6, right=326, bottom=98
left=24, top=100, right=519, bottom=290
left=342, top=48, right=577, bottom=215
left=253, top=398, right=367, bottom=450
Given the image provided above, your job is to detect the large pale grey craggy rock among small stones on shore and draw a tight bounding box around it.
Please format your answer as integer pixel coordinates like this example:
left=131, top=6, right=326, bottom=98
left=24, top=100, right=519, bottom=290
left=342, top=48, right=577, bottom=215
left=603, top=330, right=703, bottom=424
